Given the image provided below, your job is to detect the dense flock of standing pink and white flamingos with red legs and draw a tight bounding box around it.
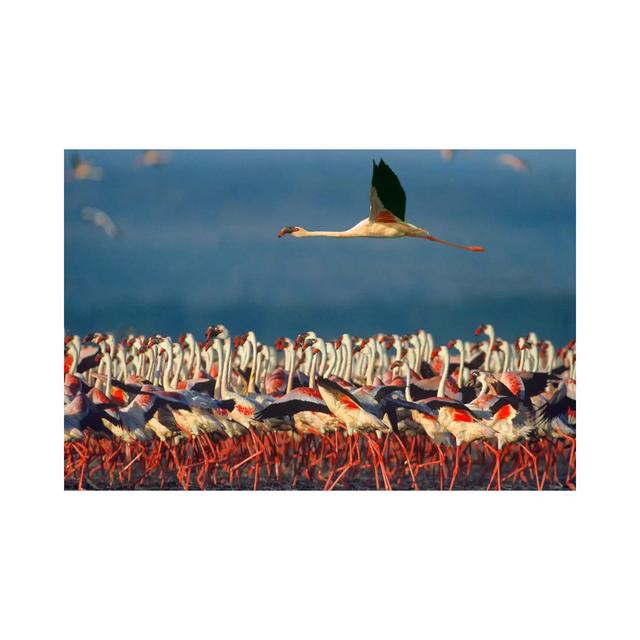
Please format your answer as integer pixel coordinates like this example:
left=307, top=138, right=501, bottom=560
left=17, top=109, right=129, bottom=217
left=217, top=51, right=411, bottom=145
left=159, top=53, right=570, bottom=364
left=64, top=324, right=576, bottom=490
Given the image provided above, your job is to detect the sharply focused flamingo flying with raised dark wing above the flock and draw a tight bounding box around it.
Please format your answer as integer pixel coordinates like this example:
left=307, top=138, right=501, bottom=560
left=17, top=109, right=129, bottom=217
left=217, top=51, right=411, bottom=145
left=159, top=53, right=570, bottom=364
left=278, top=159, right=484, bottom=251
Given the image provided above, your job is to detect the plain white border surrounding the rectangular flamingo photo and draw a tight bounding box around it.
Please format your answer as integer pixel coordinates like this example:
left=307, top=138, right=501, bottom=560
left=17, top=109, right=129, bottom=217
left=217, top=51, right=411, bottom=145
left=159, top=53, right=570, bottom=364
left=0, top=0, right=640, bottom=640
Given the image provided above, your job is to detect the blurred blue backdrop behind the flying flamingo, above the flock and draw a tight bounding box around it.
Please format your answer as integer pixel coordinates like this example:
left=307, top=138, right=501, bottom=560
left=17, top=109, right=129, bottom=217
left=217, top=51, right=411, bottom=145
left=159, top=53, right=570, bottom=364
left=64, top=150, right=576, bottom=344
